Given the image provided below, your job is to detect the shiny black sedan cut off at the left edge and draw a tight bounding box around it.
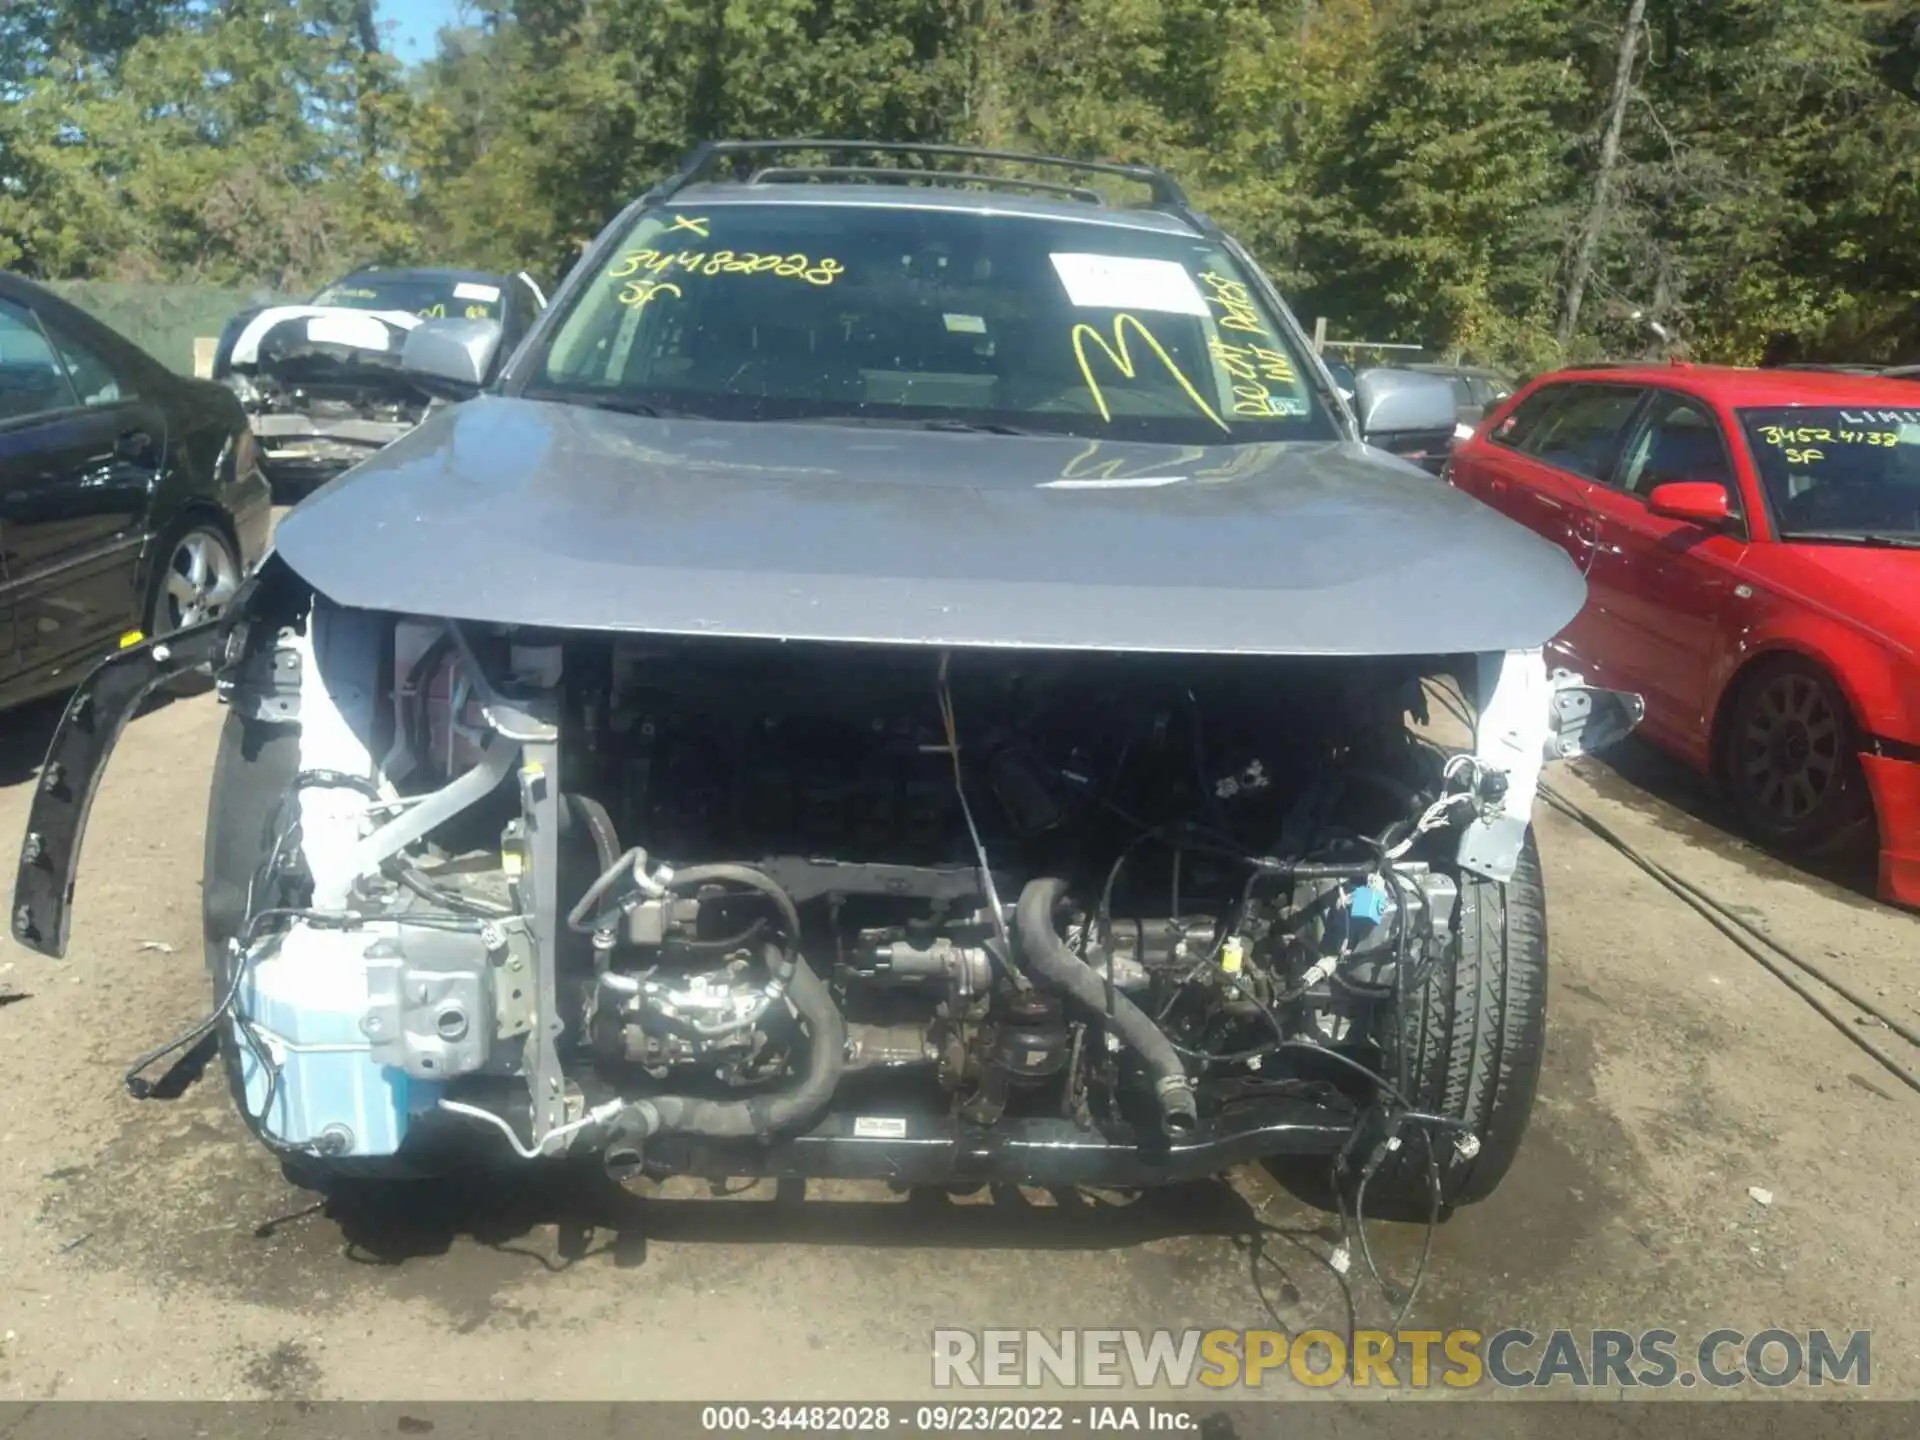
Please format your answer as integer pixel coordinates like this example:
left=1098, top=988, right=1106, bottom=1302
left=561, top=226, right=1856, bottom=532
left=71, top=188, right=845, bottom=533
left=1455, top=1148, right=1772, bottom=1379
left=0, top=275, right=273, bottom=707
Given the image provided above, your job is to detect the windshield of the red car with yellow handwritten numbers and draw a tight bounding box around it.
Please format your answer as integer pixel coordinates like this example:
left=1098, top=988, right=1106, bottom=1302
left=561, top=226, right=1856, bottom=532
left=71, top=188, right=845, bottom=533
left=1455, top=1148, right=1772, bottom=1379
left=1740, top=405, right=1920, bottom=543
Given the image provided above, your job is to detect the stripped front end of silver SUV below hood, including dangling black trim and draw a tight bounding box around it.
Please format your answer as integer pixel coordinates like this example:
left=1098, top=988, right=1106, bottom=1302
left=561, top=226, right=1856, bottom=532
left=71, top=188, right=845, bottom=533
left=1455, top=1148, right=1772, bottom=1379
left=13, top=561, right=1638, bottom=1206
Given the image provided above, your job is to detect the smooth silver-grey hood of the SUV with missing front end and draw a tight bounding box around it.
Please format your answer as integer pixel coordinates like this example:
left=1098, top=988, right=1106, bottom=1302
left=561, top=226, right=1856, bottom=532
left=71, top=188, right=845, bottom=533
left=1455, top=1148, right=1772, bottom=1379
left=276, top=397, right=1586, bottom=655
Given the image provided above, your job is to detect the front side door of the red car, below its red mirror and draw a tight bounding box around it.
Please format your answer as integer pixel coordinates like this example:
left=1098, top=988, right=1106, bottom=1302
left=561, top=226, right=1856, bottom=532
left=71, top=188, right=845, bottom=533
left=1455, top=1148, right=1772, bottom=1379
left=1586, top=390, right=1747, bottom=760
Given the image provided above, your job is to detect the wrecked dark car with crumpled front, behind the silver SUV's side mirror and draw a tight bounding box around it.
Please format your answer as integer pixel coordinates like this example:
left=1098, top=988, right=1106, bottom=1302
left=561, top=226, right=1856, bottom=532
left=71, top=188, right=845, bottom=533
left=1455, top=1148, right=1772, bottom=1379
left=213, top=265, right=547, bottom=501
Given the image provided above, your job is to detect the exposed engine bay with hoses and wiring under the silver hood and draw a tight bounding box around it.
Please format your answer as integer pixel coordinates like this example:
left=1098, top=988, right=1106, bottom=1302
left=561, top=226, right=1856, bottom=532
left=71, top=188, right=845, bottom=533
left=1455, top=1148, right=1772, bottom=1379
left=220, top=611, right=1484, bottom=1164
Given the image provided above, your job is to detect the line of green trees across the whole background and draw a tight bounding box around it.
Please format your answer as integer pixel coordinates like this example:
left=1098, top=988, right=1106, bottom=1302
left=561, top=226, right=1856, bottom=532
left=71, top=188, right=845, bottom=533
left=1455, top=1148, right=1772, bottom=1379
left=0, top=0, right=1920, bottom=369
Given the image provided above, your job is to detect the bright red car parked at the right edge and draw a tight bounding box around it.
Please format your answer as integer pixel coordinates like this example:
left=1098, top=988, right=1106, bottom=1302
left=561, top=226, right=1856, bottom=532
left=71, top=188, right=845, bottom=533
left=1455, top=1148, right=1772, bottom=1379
left=1450, top=365, right=1920, bottom=906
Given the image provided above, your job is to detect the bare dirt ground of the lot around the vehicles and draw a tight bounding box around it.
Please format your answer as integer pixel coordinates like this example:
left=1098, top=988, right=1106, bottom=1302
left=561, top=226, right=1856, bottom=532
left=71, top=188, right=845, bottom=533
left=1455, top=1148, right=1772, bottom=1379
left=0, top=637, right=1920, bottom=1400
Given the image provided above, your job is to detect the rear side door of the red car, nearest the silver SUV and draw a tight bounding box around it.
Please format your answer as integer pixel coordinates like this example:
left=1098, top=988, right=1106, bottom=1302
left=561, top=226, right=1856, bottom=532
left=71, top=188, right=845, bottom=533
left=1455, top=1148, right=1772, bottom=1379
left=1453, top=380, right=1645, bottom=684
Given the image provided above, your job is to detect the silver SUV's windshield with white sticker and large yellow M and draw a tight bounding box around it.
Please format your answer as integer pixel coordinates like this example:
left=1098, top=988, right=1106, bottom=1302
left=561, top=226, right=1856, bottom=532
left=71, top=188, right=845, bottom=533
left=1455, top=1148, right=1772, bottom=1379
left=524, top=204, right=1338, bottom=444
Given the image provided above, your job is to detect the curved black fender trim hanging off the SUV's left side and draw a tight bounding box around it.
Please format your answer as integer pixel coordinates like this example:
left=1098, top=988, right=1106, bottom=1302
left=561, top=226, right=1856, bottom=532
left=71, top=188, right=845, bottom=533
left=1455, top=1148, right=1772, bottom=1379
left=12, top=620, right=227, bottom=960
